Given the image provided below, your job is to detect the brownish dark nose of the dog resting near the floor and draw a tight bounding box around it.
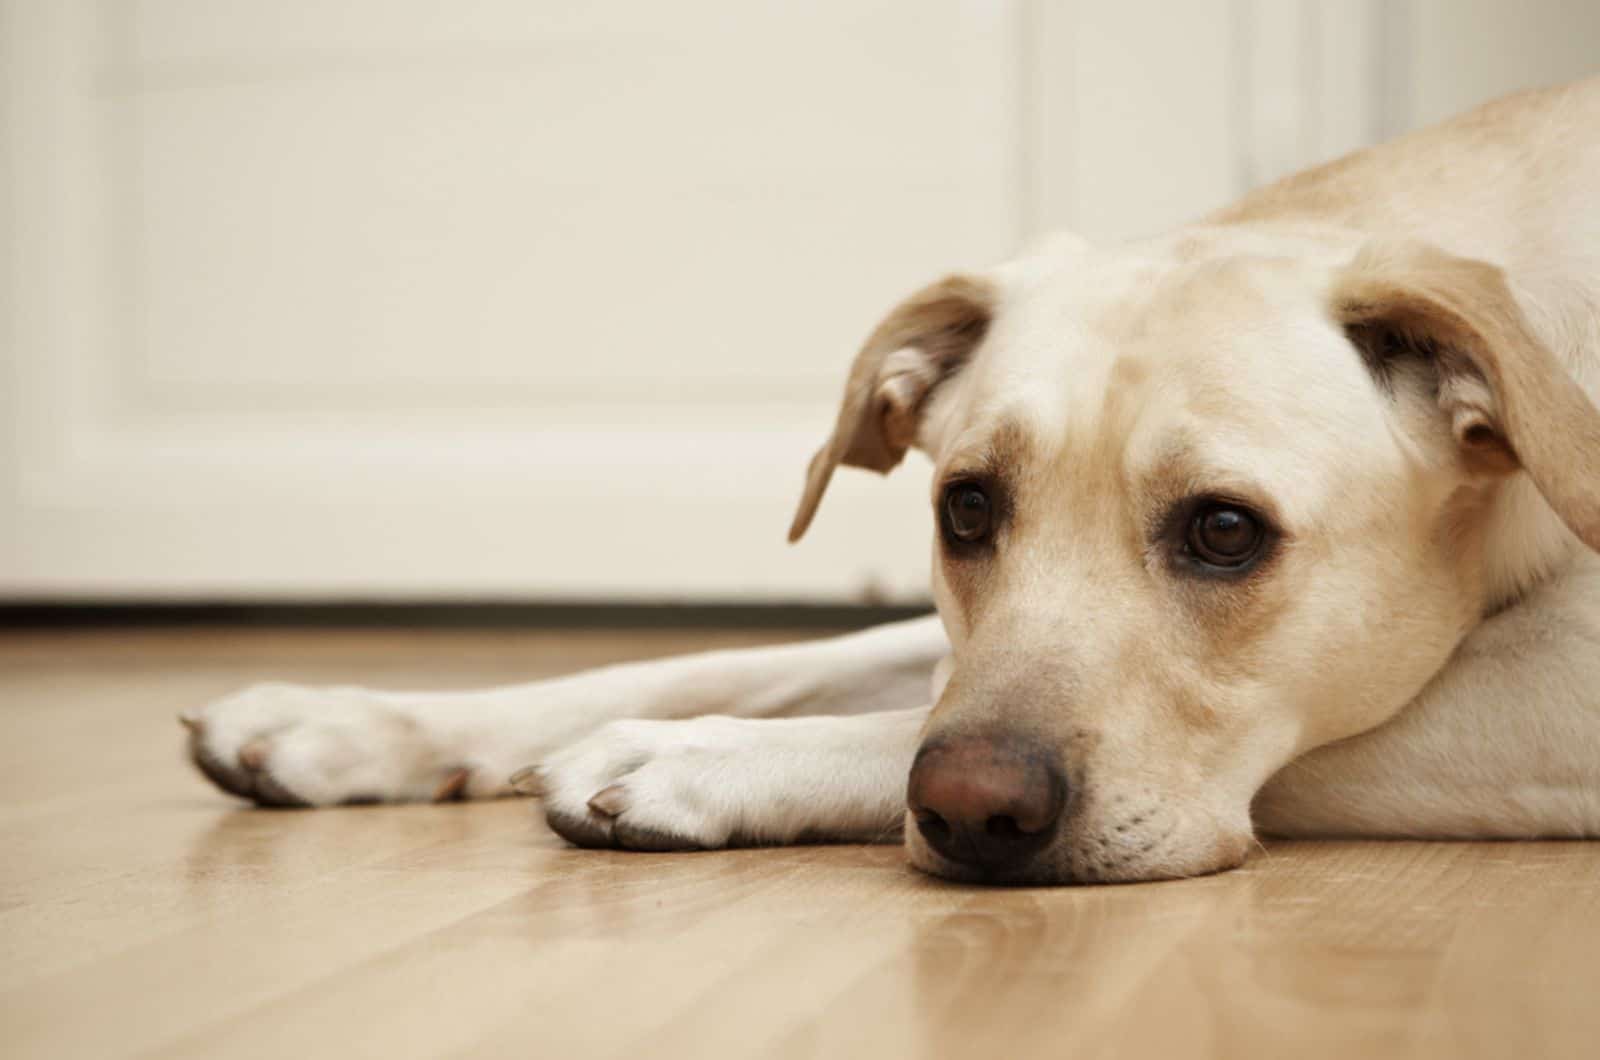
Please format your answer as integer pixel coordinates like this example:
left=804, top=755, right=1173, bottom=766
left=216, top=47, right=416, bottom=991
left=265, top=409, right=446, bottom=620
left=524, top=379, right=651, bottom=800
left=906, top=735, right=1067, bottom=869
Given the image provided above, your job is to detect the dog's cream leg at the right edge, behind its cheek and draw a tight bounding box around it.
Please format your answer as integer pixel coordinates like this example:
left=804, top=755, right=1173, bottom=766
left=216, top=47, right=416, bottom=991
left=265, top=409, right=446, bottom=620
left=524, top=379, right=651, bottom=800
left=1254, top=554, right=1600, bottom=839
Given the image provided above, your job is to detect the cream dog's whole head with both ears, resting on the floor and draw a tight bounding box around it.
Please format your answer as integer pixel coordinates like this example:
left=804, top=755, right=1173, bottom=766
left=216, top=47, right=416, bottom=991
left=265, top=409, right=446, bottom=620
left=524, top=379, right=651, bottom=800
left=792, top=231, right=1600, bottom=882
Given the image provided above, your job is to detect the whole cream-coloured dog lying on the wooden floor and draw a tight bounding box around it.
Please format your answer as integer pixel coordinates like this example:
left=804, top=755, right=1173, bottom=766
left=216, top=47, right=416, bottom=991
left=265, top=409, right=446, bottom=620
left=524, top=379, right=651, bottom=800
left=184, top=78, right=1600, bottom=882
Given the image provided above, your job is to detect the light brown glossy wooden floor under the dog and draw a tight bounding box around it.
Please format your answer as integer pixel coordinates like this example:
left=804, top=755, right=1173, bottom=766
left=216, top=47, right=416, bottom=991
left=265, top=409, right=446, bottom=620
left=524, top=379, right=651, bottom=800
left=0, top=631, right=1600, bottom=1060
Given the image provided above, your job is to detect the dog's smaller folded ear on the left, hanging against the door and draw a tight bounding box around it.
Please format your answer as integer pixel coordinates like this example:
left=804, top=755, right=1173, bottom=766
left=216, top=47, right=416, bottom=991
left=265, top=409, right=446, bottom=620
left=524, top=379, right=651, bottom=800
left=789, top=275, right=998, bottom=541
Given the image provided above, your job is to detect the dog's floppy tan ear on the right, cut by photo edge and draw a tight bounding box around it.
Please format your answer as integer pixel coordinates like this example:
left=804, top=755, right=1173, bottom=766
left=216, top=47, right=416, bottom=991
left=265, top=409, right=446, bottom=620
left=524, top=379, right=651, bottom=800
left=1334, top=245, right=1600, bottom=551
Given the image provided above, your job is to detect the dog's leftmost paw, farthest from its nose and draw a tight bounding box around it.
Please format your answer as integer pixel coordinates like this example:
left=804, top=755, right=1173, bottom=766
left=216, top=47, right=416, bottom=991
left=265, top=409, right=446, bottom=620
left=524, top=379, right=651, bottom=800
left=181, top=684, right=485, bottom=805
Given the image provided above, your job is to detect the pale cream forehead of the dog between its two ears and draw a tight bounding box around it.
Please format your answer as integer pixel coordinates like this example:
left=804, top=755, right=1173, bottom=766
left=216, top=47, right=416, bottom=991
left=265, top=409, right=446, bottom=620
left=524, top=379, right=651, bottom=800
left=968, top=240, right=1387, bottom=521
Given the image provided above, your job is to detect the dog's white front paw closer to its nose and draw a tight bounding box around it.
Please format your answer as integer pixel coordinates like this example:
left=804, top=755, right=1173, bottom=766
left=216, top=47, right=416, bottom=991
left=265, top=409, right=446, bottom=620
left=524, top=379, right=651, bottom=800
left=538, top=717, right=755, bottom=850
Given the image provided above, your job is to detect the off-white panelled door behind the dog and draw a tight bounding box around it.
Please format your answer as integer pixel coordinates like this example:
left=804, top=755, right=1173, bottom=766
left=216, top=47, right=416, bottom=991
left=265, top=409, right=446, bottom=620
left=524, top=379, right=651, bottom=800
left=0, top=0, right=1592, bottom=600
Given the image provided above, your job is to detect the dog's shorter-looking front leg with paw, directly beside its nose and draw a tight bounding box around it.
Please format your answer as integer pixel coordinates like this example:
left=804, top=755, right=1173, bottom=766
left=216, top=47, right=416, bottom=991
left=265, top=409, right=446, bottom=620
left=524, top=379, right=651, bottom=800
left=539, top=706, right=930, bottom=850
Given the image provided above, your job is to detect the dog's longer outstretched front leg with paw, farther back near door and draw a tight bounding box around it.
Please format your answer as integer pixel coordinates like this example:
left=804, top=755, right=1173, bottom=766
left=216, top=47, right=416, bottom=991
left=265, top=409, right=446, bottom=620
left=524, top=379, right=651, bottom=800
left=184, top=616, right=947, bottom=805
